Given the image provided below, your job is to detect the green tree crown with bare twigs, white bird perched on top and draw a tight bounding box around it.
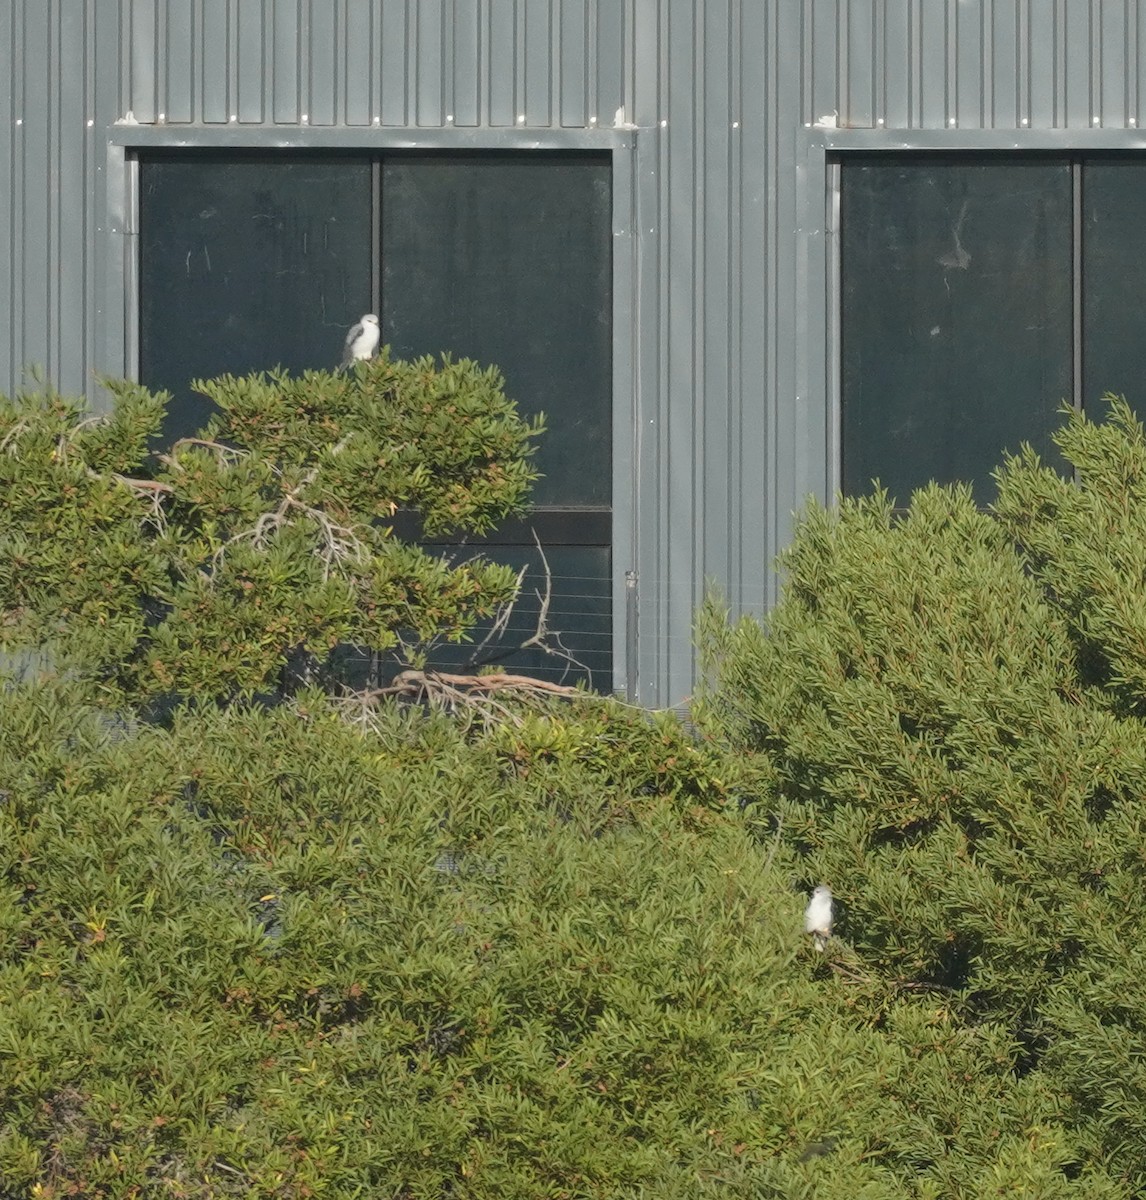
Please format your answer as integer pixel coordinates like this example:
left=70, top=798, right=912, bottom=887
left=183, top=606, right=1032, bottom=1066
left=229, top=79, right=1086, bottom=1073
left=0, top=353, right=542, bottom=702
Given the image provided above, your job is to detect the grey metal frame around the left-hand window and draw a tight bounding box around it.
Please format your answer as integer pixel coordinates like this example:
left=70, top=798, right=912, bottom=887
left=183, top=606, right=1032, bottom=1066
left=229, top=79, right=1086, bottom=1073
left=104, top=122, right=643, bottom=701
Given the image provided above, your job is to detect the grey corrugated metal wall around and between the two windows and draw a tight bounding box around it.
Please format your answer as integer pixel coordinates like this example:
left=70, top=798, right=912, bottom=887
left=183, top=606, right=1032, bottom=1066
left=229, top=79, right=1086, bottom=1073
left=0, top=0, right=1146, bottom=703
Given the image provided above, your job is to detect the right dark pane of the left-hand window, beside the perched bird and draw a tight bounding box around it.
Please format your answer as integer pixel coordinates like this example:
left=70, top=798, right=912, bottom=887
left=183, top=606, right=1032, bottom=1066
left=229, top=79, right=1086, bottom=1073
left=382, top=154, right=612, bottom=505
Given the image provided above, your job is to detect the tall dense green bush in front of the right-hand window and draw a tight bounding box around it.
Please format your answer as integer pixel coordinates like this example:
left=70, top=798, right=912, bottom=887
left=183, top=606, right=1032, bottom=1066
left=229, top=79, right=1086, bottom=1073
left=698, top=401, right=1146, bottom=1195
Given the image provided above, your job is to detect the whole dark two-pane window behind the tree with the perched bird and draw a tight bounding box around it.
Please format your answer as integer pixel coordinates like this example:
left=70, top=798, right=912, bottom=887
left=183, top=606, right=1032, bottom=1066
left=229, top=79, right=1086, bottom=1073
left=140, top=152, right=612, bottom=689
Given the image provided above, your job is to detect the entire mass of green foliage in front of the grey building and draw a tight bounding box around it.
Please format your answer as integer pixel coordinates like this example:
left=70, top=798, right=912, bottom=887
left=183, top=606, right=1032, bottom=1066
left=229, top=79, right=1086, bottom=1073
left=8, top=376, right=1146, bottom=1200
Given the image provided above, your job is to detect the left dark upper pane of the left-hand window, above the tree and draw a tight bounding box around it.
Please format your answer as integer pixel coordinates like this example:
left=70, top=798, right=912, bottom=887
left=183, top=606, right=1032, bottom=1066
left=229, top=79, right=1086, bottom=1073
left=139, top=155, right=371, bottom=434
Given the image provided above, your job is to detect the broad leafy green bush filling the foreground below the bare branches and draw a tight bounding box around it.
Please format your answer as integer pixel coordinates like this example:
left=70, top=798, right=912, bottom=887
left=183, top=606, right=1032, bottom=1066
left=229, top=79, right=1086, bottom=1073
left=0, top=686, right=1113, bottom=1200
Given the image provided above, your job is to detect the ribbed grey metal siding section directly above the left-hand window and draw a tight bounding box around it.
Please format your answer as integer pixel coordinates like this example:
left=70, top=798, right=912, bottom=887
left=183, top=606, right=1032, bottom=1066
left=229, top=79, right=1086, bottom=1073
left=95, top=0, right=635, bottom=128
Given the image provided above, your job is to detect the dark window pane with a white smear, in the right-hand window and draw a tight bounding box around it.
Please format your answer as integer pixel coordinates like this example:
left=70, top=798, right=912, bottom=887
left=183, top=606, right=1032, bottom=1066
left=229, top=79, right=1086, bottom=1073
left=841, top=156, right=1073, bottom=503
